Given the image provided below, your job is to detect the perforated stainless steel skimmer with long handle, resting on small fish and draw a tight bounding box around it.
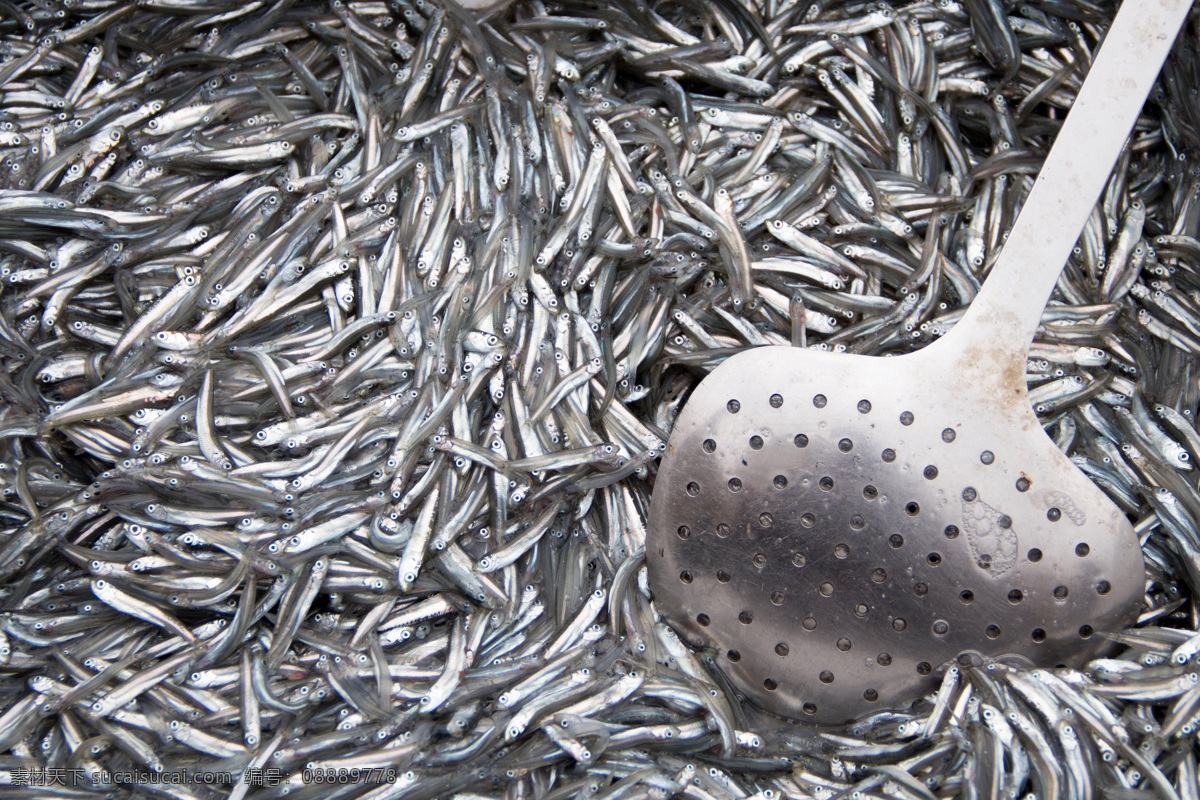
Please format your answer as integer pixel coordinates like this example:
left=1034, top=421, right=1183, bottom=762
left=647, top=0, right=1189, bottom=723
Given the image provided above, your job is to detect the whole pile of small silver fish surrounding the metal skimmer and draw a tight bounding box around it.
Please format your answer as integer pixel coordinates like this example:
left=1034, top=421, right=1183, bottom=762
left=0, top=0, right=1200, bottom=800
